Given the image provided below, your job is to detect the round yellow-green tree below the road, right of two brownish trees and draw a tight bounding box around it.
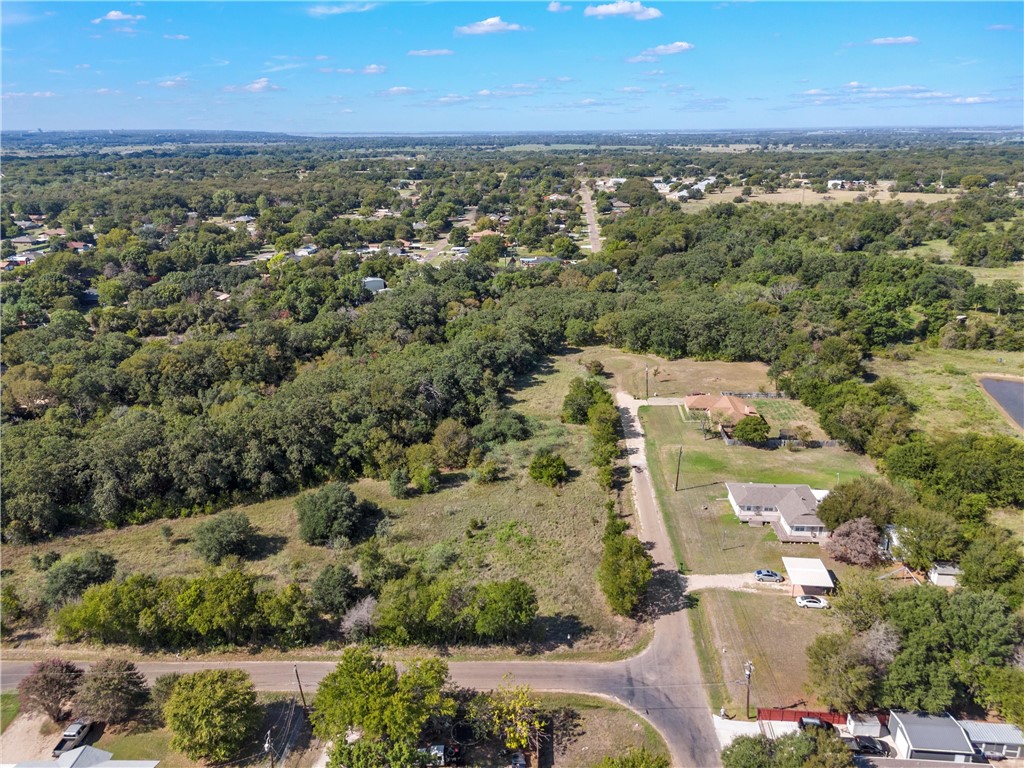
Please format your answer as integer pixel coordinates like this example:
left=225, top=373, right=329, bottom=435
left=164, top=670, right=261, bottom=763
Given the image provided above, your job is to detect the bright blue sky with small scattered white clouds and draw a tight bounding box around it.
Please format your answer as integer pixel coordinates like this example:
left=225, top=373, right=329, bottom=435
left=0, top=0, right=1024, bottom=133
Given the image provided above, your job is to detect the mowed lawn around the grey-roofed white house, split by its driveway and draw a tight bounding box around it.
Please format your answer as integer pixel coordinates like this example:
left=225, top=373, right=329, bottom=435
left=640, top=407, right=872, bottom=716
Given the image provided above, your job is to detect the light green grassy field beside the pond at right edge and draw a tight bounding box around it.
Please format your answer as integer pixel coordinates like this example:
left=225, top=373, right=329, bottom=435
left=866, top=346, right=1024, bottom=434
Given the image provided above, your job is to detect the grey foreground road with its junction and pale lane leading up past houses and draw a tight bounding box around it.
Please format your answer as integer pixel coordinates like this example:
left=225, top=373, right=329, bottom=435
left=0, top=392, right=720, bottom=768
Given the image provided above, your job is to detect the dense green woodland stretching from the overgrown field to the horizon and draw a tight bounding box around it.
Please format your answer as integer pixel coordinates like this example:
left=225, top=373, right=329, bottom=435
left=0, top=136, right=1024, bottom=700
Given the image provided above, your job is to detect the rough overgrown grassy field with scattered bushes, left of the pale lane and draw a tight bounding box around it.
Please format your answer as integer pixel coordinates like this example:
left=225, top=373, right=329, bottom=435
left=4, top=358, right=649, bottom=656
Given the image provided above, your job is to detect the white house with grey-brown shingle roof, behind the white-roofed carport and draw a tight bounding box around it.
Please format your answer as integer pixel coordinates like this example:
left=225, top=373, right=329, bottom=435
left=725, top=482, right=828, bottom=542
